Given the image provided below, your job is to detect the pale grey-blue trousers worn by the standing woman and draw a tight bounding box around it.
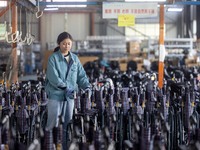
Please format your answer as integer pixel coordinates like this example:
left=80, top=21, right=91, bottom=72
left=46, top=100, right=74, bottom=150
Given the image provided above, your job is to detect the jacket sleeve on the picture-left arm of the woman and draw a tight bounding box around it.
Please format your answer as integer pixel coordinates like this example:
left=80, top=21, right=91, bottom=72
left=46, top=57, right=67, bottom=89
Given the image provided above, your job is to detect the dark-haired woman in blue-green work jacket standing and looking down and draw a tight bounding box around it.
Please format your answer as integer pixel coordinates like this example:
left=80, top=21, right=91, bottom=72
left=45, top=32, right=91, bottom=150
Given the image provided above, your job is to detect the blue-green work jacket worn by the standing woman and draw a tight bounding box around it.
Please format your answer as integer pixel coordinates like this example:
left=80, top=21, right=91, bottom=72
left=45, top=50, right=90, bottom=101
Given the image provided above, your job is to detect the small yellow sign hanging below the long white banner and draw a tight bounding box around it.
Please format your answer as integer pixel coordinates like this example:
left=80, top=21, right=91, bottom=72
left=118, top=14, right=135, bottom=27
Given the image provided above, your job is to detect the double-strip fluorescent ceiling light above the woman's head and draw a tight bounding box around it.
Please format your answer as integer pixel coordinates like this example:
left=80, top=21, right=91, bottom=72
left=46, top=0, right=87, bottom=8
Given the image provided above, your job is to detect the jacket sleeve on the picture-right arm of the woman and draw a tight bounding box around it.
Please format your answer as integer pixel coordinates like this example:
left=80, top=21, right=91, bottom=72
left=77, top=58, right=91, bottom=89
